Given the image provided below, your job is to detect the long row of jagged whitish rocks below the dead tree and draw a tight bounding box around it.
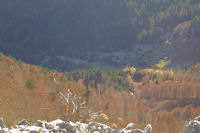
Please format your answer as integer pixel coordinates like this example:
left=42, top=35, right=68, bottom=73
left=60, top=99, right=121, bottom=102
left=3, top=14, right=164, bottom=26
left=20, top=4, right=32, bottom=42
left=0, top=118, right=152, bottom=133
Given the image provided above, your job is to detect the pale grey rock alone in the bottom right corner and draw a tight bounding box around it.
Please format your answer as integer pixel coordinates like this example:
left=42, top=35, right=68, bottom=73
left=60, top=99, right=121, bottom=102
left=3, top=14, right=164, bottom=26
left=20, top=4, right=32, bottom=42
left=181, top=116, right=200, bottom=133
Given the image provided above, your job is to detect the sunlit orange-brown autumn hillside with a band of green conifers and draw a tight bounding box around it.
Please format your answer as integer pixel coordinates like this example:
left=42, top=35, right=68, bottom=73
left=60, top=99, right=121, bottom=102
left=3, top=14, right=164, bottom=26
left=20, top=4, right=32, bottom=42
left=0, top=54, right=200, bottom=133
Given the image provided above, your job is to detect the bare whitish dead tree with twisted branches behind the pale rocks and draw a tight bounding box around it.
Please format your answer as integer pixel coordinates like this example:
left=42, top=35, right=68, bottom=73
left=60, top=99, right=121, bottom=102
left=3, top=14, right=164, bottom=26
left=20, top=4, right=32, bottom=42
left=53, top=78, right=102, bottom=122
